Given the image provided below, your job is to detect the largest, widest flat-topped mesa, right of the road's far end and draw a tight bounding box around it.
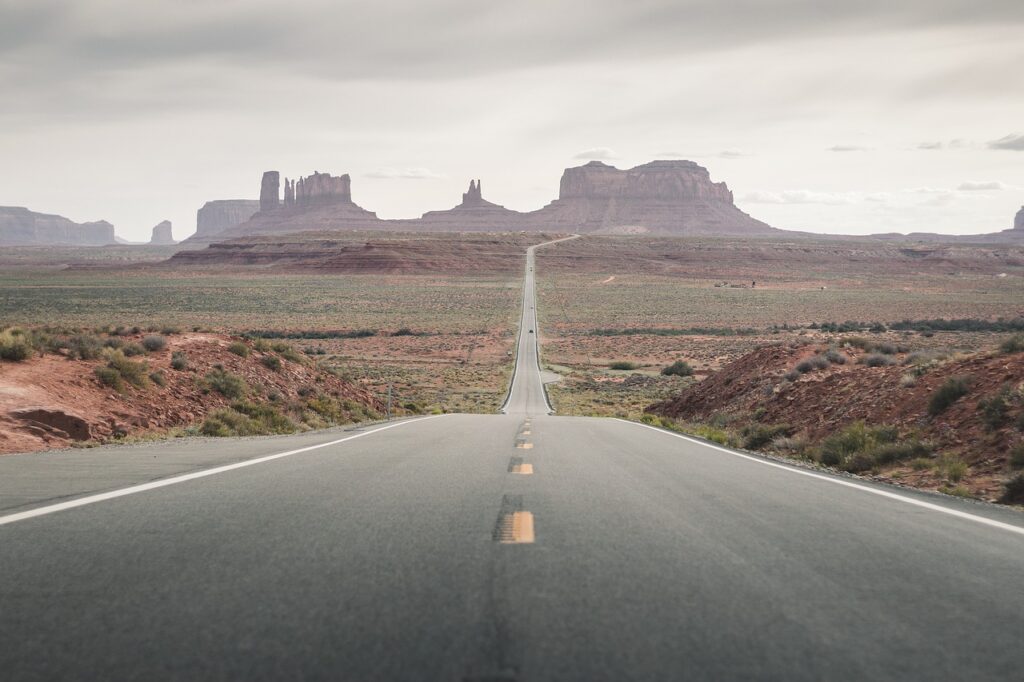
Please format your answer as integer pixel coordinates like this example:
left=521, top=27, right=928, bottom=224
left=529, top=161, right=779, bottom=235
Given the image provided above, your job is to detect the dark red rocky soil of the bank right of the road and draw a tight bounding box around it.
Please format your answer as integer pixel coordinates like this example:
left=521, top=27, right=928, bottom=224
left=648, top=344, right=1024, bottom=500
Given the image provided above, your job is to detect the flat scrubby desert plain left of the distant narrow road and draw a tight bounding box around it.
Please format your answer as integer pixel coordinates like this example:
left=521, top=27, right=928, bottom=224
left=0, top=268, right=521, bottom=412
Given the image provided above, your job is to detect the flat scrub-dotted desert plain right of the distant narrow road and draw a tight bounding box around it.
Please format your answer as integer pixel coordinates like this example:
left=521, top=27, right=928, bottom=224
left=538, top=237, right=1024, bottom=417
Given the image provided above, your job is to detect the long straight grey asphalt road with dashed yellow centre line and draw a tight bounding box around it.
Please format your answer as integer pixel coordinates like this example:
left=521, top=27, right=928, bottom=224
left=0, top=236, right=1024, bottom=682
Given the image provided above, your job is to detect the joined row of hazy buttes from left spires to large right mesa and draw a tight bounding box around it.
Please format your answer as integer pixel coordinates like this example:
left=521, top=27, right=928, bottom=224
left=193, top=161, right=782, bottom=241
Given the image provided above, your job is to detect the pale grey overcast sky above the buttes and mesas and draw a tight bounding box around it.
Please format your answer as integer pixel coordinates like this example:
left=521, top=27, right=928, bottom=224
left=0, top=0, right=1024, bottom=240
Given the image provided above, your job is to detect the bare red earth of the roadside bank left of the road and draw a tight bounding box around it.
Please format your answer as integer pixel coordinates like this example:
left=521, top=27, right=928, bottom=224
left=0, top=334, right=382, bottom=454
